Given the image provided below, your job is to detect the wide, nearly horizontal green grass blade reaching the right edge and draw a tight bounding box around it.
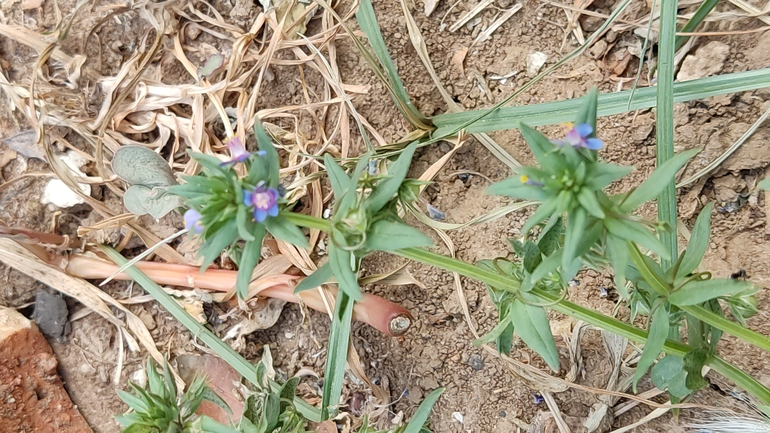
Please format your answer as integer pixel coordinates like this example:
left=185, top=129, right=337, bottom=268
left=432, top=68, right=770, bottom=137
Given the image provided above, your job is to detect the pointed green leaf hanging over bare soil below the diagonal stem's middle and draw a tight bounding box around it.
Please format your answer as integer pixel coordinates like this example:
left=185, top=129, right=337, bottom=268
left=511, top=300, right=559, bottom=372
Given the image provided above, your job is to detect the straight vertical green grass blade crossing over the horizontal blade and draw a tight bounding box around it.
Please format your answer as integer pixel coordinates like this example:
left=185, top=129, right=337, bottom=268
left=655, top=0, right=679, bottom=268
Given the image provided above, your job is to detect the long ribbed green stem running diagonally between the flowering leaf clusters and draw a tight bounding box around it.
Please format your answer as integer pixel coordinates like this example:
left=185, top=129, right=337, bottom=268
left=286, top=213, right=770, bottom=405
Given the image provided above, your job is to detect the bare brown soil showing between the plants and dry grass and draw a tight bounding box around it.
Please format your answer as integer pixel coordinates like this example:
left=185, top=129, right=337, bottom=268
left=0, top=0, right=770, bottom=433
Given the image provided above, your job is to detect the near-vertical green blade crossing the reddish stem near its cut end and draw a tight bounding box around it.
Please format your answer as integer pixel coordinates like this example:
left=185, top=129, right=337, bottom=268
left=321, top=290, right=357, bottom=419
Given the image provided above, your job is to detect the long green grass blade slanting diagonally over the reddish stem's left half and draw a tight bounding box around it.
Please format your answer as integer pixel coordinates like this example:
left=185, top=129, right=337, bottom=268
left=100, top=245, right=321, bottom=422
